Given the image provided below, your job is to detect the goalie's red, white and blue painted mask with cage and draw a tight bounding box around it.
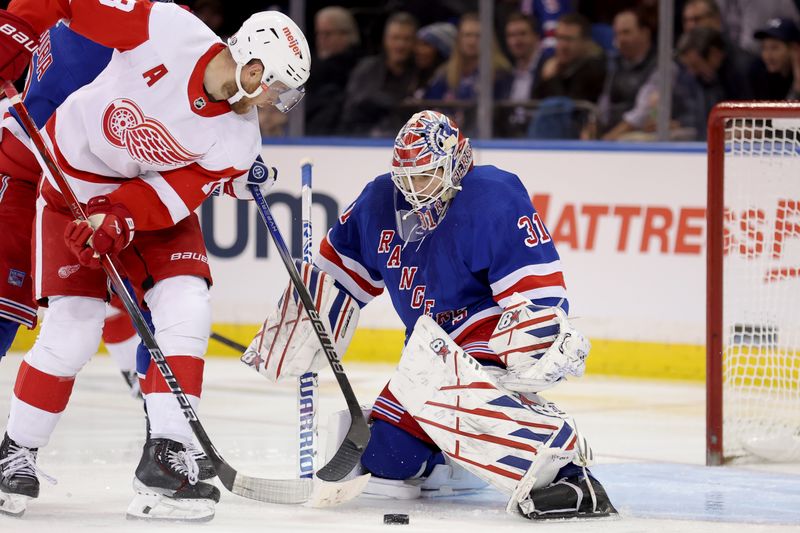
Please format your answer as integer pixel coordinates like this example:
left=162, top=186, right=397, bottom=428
left=392, top=110, right=472, bottom=230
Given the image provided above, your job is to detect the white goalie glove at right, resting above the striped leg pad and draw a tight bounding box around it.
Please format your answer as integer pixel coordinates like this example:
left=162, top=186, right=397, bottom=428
left=489, top=293, right=591, bottom=392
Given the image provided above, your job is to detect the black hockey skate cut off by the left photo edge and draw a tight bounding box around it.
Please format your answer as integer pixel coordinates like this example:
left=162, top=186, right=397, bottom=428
left=0, top=434, right=55, bottom=516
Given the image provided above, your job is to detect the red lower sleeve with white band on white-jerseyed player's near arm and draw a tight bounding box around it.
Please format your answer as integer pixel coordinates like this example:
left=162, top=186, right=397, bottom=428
left=108, top=163, right=247, bottom=231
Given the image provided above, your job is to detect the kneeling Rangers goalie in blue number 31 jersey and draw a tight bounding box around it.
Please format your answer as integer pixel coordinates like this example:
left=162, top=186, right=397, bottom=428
left=242, top=111, right=616, bottom=519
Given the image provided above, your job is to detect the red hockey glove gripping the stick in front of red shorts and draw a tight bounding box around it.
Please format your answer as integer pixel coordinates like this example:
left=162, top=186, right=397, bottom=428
left=64, top=196, right=134, bottom=268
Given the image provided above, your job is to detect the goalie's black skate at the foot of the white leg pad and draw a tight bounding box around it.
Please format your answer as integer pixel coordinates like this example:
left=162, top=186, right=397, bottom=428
left=519, top=474, right=617, bottom=520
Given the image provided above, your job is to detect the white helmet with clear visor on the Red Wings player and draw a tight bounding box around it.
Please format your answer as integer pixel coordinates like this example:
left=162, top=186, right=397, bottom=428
left=228, top=11, right=311, bottom=113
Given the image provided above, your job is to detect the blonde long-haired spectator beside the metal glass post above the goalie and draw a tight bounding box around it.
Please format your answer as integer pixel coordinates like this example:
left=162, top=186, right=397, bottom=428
left=424, top=13, right=511, bottom=135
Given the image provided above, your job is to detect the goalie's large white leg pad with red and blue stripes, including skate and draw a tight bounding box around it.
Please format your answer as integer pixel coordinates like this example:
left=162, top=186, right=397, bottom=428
left=389, top=311, right=616, bottom=519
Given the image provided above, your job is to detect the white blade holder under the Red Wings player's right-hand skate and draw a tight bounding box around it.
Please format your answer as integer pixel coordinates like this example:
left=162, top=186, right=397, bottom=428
left=125, top=478, right=215, bottom=522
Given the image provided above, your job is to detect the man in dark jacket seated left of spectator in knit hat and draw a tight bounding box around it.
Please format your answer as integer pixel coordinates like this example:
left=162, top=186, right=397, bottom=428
left=340, top=11, right=417, bottom=137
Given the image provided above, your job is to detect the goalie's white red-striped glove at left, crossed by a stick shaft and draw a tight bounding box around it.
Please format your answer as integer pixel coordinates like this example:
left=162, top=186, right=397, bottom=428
left=242, top=261, right=359, bottom=382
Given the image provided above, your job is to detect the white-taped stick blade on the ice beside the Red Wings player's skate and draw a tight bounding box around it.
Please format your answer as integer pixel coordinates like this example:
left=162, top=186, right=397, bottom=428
left=217, top=464, right=313, bottom=504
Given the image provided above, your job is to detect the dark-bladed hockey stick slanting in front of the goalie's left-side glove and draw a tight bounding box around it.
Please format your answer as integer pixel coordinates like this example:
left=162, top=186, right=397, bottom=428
left=250, top=181, right=369, bottom=481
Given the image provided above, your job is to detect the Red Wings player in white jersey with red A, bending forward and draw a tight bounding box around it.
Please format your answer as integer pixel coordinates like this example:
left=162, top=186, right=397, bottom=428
left=0, top=0, right=310, bottom=520
